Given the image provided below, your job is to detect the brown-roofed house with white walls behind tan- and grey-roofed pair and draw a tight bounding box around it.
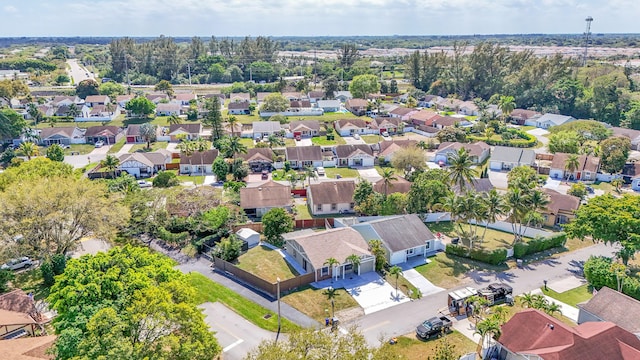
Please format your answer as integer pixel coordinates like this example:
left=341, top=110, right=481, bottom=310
left=307, top=180, right=356, bottom=215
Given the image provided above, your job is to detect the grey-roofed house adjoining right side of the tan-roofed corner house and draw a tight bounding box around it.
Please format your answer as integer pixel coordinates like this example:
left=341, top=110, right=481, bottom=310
left=351, top=214, right=436, bottom=265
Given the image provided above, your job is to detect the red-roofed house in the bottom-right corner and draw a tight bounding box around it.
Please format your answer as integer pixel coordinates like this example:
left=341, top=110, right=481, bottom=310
left=498, top=309, right=640, bottom=360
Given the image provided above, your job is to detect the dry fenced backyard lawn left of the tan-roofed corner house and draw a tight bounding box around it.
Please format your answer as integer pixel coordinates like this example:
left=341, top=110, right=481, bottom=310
left=237, top=246, right=297, bottom=283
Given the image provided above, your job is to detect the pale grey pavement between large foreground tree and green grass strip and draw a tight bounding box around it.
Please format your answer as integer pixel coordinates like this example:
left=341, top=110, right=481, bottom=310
left=200, top=302, right=282, bottom=360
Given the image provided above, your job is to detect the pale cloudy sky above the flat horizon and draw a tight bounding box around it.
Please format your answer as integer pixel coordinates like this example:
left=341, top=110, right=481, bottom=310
left=0, top=0, right=640, bottom=37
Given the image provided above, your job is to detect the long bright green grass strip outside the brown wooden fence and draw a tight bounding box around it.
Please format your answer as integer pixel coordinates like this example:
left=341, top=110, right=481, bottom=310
left=187, top=273, right=299, bottom=332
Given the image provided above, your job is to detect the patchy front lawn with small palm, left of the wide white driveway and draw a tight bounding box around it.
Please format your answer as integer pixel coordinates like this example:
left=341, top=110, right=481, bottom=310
left=282, top=286, right=359, bottom=323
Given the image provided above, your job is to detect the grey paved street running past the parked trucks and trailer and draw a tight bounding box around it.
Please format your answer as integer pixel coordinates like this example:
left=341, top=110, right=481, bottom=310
left=345, top=244, right=615, bottom=346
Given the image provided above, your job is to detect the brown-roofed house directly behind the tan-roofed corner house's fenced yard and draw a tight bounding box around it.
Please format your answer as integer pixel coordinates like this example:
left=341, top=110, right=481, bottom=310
left=240, top=180, right=292, bottom=218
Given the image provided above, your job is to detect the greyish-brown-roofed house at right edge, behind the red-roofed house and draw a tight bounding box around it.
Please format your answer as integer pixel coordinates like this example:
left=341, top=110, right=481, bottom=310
left=578, top=286, right=640, bottom=337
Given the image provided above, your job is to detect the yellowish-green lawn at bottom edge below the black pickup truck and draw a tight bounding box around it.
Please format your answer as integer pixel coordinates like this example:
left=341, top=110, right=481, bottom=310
left=382, top=332, right=478, bottom=359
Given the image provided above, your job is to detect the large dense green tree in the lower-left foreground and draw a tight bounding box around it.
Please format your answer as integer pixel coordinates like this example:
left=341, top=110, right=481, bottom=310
left=48, top=246, right=221, bottom=360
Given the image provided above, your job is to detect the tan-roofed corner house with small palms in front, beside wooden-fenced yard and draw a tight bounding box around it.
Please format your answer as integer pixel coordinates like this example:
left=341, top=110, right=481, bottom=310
left=285, top=227, right=375, bottom=281
